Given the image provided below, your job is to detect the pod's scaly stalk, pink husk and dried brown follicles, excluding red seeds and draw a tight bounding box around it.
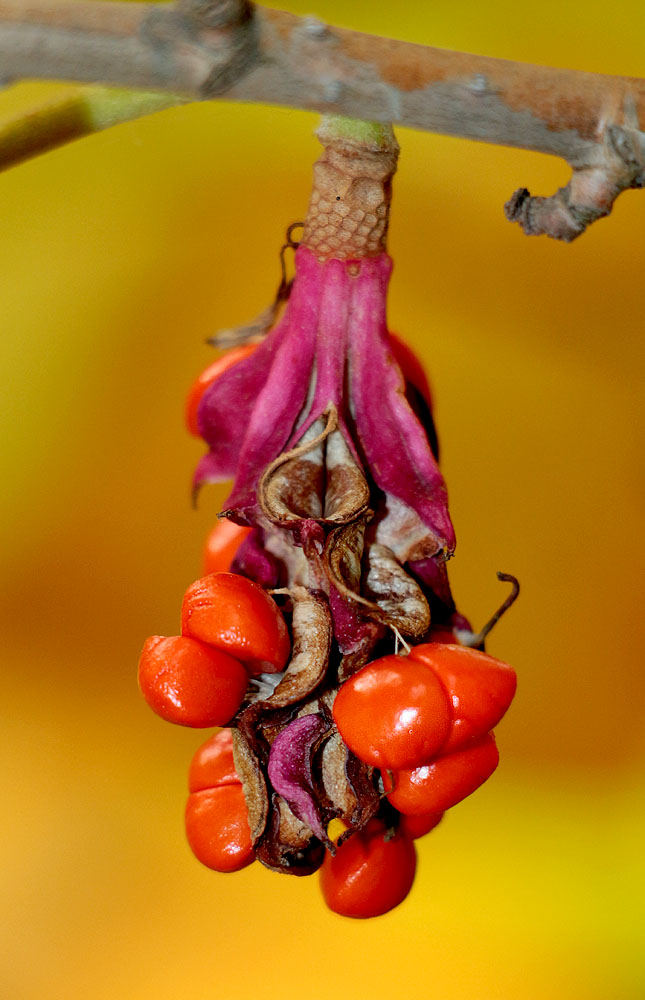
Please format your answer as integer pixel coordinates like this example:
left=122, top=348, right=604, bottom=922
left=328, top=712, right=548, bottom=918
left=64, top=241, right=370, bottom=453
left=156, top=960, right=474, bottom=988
left=189, top=118, right=490, bottom=875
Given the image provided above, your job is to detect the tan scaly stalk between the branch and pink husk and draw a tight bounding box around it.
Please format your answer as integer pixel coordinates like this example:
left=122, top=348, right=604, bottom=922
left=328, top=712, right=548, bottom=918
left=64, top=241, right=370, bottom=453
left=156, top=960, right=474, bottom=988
left=302, top=117, right=399, bottom=261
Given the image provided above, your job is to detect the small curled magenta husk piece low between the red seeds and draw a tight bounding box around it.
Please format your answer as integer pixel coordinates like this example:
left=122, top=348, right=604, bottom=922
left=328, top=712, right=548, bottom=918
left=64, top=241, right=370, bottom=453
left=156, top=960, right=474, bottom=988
left=268, top=715, right=329, bottom=842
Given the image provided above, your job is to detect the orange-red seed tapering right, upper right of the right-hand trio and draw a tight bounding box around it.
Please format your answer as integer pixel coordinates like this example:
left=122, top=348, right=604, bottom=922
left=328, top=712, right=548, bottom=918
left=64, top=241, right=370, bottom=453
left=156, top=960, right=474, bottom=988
left=410, top=642, right=517, bottom=754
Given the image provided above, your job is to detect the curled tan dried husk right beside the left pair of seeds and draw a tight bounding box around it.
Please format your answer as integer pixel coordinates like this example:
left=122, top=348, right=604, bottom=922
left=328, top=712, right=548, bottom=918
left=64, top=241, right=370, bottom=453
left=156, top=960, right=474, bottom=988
left=267, top=587, right=332, bottom=708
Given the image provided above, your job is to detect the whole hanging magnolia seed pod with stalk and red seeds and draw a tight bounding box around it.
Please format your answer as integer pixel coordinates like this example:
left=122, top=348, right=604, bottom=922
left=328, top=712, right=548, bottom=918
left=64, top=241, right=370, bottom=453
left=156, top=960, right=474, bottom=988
left=139, top=119, right=515, bottom=917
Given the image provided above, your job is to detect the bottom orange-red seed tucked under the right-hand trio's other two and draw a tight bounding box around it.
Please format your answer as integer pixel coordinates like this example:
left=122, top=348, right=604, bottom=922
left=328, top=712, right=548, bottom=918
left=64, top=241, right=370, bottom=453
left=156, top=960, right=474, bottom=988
left=383, top=733, right=499, bottom=816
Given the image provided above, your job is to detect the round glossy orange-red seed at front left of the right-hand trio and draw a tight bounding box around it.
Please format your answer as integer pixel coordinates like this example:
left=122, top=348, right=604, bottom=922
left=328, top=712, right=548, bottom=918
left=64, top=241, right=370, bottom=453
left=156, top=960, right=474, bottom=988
left=333, top=656, right=450, bottom=769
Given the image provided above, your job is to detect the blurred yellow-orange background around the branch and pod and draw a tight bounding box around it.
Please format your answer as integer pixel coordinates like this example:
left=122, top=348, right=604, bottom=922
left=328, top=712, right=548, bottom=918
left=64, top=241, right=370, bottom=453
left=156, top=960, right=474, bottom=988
left=0, top=0, right=645, bottom=1000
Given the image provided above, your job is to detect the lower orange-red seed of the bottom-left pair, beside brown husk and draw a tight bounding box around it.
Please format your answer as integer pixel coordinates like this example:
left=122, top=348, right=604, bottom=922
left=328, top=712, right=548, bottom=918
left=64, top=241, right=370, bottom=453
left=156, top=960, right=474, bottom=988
left=185, top=784, right=255, bottom=872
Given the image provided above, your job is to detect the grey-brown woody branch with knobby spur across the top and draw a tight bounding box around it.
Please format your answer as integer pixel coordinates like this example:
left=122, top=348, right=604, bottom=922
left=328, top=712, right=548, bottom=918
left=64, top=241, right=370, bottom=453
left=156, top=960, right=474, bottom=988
left=0, top=0, right=645, bottom=240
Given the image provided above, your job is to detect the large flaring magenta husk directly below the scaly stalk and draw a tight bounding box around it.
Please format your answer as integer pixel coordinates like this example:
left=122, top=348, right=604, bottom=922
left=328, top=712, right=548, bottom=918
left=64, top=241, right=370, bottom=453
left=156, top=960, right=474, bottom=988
left=198, top=247, right=455, bottom=550
